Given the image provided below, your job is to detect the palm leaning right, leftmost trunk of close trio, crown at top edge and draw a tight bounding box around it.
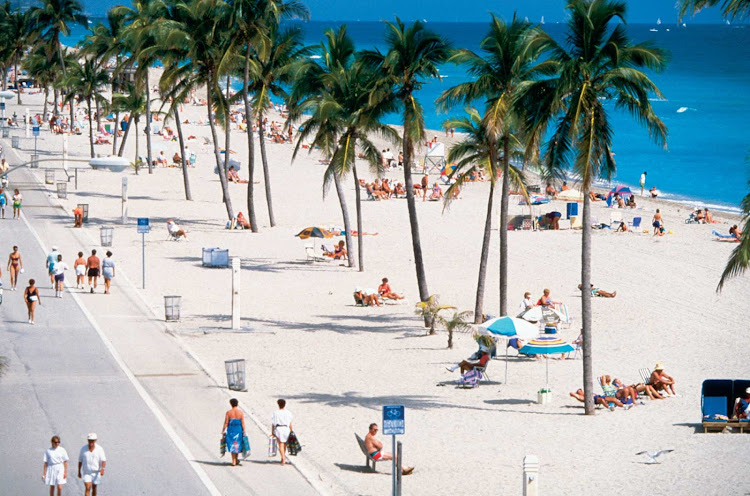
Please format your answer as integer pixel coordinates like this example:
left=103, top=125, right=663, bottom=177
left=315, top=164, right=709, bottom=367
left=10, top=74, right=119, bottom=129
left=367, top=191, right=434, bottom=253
left=157, top=0, right=234, bottom=219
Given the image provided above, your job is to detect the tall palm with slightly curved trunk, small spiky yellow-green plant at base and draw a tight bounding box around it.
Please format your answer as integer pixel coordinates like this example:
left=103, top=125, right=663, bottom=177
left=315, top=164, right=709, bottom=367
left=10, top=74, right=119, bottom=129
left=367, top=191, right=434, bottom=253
left=361, top=17, right=451, bottom=302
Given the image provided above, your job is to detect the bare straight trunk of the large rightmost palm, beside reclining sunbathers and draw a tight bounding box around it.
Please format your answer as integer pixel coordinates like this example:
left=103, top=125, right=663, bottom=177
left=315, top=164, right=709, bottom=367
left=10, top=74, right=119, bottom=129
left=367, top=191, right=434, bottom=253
left=581, top=188, right=595, bottom=415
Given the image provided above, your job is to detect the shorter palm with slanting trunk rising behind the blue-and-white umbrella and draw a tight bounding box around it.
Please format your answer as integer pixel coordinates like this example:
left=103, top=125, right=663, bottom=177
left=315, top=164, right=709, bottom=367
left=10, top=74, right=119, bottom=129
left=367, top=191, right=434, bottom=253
left=445, top=108, right=526, bottom=324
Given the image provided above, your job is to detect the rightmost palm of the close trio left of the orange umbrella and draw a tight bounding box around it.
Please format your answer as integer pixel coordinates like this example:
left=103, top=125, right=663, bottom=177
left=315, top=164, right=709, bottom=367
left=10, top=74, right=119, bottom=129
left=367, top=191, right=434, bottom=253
left=246, top=21, right=309, bottom=227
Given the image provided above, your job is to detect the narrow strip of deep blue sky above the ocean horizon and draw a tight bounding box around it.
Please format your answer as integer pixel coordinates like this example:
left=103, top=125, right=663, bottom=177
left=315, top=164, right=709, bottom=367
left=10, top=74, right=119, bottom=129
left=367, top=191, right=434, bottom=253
left=67, top=0, right=732, bottom=24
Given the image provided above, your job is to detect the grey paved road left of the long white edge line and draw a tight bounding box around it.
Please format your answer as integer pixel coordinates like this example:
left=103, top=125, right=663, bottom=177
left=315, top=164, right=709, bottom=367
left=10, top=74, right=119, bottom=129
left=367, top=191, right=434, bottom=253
left=0, top=171, right=209, bottom=496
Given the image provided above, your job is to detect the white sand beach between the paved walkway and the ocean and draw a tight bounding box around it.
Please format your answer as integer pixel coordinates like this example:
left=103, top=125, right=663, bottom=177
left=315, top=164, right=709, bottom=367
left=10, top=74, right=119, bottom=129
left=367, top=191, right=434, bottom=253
left=3, top=71, right=750, bottom=495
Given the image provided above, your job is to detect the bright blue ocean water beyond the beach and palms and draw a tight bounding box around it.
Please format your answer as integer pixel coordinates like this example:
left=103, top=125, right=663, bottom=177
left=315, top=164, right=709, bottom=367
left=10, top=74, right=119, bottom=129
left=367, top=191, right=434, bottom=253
left=64, top=20, right=750, bottom=211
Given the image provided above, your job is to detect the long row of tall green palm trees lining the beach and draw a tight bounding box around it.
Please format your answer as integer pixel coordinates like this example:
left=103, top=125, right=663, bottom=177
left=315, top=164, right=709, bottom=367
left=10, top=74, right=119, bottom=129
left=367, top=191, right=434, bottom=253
left=0, top=0, right=668, bottom=413
